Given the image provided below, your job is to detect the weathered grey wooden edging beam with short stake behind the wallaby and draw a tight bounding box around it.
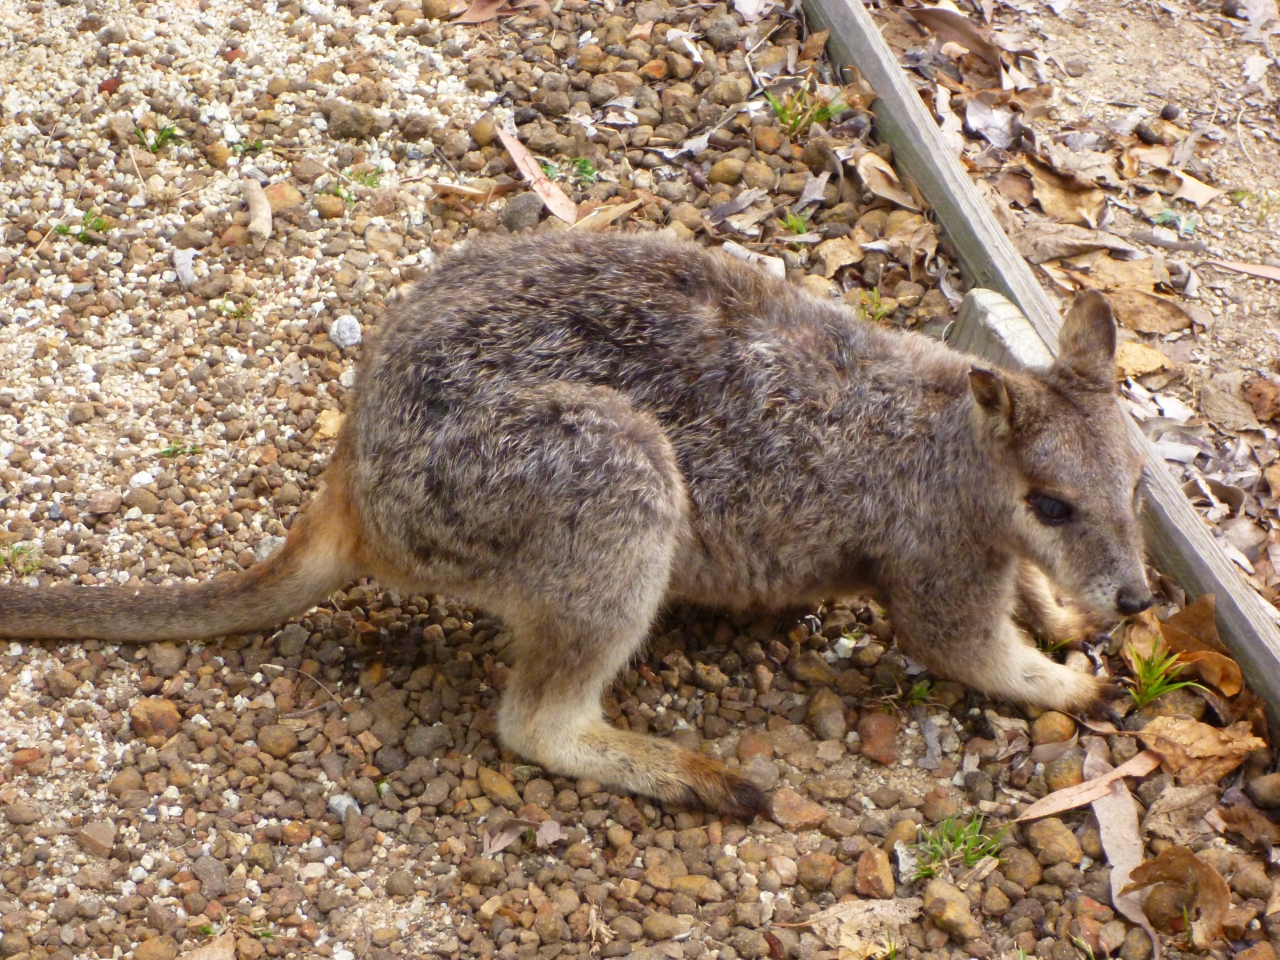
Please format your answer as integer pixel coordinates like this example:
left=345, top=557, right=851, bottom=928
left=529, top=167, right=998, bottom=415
left=804, top=0, right=1280, bottom=728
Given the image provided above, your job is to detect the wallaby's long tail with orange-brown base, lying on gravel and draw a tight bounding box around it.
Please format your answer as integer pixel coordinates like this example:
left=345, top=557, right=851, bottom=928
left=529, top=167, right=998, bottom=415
left=0, top=468, right=360, bottom=643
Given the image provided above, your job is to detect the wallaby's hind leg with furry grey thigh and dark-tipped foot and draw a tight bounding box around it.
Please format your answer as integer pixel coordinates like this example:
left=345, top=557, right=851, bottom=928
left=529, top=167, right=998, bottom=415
left=370, top=384, right=764, bottom=814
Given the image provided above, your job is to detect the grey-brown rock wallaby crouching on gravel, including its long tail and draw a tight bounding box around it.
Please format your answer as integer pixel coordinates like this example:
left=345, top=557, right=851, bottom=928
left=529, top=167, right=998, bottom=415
left=0, top=234, right=1151, bottom=814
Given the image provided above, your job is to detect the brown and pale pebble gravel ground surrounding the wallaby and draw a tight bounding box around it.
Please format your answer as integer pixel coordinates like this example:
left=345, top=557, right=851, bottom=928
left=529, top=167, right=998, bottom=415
left=0, top=0, right=1280, bottom=960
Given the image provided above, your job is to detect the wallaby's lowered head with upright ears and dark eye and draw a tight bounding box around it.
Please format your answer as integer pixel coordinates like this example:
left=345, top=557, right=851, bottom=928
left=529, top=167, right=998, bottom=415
left=969, top=291, right=1151, bottom=618
